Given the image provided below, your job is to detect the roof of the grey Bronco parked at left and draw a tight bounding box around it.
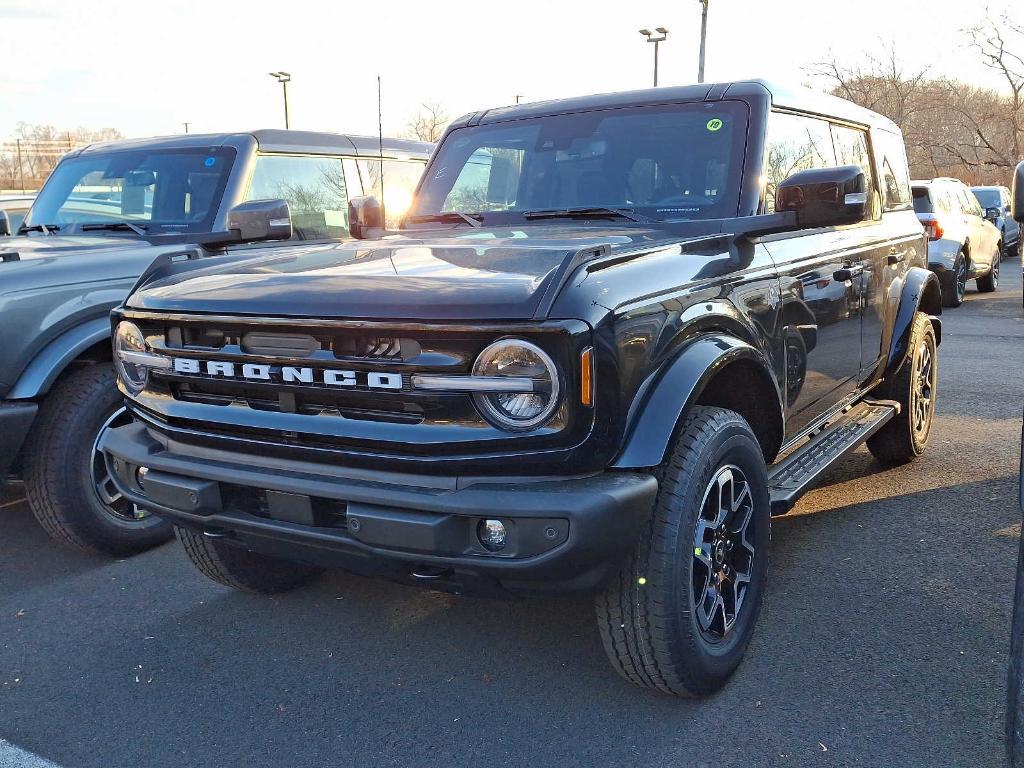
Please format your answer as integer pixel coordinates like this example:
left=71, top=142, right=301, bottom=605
left=73, top=128, right=434, bottom=160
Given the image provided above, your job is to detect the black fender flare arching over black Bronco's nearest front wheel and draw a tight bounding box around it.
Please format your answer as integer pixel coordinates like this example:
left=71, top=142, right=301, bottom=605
left=611, top=334, right=782, bottom=469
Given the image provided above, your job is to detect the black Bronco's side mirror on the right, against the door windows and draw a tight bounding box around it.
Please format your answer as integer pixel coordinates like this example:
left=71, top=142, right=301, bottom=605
left=775, top=165, right=867, bottom=229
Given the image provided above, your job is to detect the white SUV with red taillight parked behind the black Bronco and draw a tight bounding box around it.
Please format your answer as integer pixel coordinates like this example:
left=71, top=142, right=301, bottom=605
left=913, top=178, right=1002, bottom=307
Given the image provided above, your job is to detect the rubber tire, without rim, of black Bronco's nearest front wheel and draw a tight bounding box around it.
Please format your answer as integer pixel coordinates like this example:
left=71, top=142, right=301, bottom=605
left=595, top=407, right=770, bottom=696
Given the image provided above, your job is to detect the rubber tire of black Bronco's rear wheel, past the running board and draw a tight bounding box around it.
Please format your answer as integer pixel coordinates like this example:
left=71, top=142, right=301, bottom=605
left=867, top=312, right=938, bottom=467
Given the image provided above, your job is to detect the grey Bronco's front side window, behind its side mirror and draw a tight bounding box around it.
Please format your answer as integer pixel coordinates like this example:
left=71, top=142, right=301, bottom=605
left=246, top=155, right=348, bottom=240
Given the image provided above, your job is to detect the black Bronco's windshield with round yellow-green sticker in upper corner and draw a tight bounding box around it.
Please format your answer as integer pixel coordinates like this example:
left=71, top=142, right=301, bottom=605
left=407, top=102, right=746, bottom=223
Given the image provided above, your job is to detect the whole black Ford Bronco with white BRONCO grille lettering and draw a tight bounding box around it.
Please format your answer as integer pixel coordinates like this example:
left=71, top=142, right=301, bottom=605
left=100, top=82, right=941, bottom=694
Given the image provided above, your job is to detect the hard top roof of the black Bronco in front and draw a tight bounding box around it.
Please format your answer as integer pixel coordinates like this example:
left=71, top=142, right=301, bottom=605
left=454, top=80, right=899, bottom=132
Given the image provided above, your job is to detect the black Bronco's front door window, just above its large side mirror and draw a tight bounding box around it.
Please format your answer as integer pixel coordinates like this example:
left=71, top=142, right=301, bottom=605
left=764, top=112, right=837, bottom=213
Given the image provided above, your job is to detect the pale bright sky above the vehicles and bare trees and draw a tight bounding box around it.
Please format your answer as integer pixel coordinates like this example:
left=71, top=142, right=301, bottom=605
left=0, top=0, right=1024, bottom=140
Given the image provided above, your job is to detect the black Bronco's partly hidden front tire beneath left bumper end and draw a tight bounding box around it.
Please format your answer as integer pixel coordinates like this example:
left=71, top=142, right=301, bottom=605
left=174, top=525, right=321, bottom=595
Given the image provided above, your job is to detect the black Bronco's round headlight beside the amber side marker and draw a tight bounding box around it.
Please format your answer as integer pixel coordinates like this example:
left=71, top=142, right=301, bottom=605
left=473, top=339, right=558, bottom=432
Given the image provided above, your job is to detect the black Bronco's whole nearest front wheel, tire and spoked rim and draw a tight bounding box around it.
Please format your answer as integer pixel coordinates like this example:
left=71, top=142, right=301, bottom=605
left=595, top=407, right=770, bottom=695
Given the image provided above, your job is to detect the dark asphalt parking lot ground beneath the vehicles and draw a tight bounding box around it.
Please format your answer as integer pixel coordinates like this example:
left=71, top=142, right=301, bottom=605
left=0, top=260, right=1024, bottom=768
